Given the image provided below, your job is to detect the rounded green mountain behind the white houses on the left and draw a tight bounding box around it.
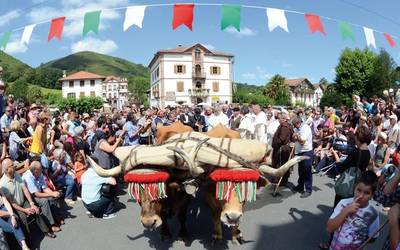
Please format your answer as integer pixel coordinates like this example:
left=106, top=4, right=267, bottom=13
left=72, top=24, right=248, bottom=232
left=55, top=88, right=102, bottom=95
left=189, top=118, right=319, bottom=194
left=39, top=51, right=149, bottom=77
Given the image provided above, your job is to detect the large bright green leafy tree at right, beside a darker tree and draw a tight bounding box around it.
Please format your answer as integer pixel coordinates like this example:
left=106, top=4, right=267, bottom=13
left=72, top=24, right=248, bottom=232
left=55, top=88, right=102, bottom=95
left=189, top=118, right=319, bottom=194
left=335, top=48, right=376, bottom=97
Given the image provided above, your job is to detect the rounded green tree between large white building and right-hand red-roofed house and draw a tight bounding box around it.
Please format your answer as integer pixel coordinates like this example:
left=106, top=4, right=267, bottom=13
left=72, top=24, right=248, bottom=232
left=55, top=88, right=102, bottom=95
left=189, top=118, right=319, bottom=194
left=264, top=75, right=290, bottom=105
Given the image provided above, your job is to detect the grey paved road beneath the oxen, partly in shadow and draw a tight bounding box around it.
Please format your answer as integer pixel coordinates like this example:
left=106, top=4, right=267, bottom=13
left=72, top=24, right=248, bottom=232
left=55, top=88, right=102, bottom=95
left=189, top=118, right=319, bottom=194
left=41, top=174, right=387, bottom=250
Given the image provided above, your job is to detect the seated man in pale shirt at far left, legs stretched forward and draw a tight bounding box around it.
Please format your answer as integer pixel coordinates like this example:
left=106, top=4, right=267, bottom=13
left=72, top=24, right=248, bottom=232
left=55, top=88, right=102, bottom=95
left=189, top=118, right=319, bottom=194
left=0, top=159, right=56, bottom=238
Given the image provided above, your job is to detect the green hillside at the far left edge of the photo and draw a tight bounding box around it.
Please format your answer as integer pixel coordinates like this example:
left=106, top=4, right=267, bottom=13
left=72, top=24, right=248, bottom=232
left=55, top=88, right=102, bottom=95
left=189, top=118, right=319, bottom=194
left=0, top=51, right=31, bottom=82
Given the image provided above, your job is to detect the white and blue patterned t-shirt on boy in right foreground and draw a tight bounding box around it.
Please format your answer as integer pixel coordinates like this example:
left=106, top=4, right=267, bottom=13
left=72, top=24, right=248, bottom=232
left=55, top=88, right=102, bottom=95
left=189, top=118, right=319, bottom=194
left=330, top=198, right=379, bottom=250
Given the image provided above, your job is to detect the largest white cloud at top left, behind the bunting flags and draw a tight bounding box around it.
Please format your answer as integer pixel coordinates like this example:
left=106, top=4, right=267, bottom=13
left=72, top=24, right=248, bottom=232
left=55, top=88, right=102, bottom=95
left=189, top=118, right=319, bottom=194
left=28, top=0, right=129, bottom=37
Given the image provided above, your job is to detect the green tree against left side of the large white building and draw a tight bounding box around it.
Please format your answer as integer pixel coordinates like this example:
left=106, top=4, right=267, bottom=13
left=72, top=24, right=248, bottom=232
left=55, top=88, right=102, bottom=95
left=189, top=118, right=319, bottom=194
left=128, top=77, right=150, bottom=105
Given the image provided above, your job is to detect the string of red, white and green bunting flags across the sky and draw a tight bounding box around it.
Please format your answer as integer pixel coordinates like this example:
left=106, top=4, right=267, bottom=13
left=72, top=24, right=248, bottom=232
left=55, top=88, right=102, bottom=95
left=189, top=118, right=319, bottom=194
left=0, top=3, right=399, bottom=49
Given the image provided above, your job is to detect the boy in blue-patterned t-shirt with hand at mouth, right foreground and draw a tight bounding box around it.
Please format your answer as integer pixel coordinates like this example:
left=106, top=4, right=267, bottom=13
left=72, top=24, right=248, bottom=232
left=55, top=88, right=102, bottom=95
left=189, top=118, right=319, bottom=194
left=326, top=171, right=379, bottom=250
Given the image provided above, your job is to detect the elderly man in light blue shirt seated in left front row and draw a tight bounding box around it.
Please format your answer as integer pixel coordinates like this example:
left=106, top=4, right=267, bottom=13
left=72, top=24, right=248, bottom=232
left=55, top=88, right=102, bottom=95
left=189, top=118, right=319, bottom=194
left=22, top=161, right=63, bottom=232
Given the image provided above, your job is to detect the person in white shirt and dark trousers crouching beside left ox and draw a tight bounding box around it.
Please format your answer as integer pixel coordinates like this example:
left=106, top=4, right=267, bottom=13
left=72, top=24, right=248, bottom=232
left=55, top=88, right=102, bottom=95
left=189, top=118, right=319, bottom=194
left=81, top=164, right=117, bottom=219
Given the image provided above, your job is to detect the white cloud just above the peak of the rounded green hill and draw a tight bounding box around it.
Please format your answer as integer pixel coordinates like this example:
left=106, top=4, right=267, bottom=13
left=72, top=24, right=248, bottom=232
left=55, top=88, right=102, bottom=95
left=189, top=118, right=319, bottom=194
left=71, top=37, right=118, bottom=54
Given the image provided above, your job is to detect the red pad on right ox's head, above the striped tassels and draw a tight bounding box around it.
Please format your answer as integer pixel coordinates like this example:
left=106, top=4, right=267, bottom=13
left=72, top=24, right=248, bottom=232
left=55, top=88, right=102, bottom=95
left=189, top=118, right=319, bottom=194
left=210, top=168, right=260, bottom=182
